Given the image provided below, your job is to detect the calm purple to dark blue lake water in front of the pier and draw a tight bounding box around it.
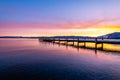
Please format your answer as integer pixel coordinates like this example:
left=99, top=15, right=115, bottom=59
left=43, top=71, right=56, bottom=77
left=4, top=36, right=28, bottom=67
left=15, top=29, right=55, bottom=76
left=0, top=39, right=120, bottom=80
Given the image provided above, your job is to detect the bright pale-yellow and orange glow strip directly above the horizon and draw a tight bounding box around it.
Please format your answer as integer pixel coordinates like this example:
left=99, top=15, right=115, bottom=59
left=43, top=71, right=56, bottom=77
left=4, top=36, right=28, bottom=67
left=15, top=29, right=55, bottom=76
left=0, top=27, right=120, bottom=37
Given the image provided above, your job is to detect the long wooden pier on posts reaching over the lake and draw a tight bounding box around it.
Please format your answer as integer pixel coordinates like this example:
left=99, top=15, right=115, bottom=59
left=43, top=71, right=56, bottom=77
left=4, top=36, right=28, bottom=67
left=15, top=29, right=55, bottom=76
left=40, top=37, right=120, bottom=50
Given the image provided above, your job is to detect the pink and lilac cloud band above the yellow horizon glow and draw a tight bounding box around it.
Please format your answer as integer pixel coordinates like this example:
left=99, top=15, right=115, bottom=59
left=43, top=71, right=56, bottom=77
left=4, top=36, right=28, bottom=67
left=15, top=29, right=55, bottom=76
left=0, top=17, right=120, bottom=30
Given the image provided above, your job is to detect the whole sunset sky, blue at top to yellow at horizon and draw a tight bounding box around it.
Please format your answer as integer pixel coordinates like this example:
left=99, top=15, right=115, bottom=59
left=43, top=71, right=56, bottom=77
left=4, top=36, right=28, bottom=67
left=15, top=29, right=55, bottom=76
left=0, top=0, right=120, bottom=36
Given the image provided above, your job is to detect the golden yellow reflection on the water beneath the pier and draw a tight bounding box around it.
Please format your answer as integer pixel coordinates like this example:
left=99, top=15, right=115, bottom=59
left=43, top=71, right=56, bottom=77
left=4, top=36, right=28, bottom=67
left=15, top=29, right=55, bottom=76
left=47, top=41, right=120, bottom=53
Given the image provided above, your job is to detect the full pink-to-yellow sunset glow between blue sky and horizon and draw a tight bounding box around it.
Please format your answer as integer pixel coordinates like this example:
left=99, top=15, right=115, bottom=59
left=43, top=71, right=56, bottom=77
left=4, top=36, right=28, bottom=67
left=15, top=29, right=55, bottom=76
left=0, top=20, right=120, bottom=37
